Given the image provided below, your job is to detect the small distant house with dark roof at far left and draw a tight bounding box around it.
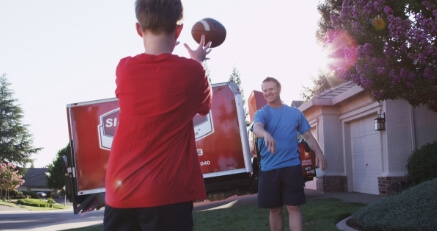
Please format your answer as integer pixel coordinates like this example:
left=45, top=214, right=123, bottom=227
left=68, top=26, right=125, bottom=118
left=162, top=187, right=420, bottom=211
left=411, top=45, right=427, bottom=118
left=18, top=168, right=51, bottom=192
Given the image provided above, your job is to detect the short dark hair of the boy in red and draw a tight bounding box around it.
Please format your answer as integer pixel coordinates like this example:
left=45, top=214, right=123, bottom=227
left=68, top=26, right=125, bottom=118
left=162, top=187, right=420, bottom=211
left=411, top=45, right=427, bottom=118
left=135, top=0, right=184, bottom=34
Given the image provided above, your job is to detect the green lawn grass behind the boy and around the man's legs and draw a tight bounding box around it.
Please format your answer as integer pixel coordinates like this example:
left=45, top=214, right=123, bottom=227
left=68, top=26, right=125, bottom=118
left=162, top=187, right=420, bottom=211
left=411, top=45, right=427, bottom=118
left=63, top=199, right=365, bottom=231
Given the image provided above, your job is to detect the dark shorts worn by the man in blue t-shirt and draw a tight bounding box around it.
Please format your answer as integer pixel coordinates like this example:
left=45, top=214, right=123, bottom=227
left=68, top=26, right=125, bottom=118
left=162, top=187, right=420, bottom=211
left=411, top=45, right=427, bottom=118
left=258, top=165, right=306, bottom=209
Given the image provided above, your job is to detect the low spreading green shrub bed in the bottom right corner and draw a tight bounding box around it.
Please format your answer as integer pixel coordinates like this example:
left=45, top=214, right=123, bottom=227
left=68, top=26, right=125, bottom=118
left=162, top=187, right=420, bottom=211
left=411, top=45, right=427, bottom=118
left=348, top=179, right=437, bottom=231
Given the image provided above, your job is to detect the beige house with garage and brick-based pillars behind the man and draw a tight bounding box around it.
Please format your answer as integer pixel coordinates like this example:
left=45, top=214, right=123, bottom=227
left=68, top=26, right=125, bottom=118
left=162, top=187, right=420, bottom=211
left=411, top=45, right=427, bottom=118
left=299, top=82, right=437, bottom=197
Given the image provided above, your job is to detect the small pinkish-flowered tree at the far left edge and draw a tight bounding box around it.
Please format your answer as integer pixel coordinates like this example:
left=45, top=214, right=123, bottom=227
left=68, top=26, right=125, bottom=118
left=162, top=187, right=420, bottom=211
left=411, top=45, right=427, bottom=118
left=0, top=163, right=24, bottom=200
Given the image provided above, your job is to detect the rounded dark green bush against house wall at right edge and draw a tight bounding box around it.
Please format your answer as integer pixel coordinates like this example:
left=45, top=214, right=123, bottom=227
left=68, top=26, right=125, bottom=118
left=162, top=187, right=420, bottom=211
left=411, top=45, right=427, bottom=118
left=407, top=141, right=437, bottom=185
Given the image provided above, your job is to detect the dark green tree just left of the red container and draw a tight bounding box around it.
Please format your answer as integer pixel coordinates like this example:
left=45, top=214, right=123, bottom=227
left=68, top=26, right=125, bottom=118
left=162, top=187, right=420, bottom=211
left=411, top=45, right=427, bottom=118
left=47, top=144, right=70, bottom=190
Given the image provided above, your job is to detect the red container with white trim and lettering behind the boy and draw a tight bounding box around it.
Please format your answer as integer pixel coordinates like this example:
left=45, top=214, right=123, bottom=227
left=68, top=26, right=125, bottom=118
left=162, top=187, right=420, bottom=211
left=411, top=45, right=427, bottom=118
left=64, top=82, right=258, bottom=214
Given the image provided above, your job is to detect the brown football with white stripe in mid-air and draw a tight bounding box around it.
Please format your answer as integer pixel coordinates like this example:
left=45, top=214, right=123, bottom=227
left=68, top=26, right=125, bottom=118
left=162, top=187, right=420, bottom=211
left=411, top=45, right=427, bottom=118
left=191, top=18, right=226, bottom=47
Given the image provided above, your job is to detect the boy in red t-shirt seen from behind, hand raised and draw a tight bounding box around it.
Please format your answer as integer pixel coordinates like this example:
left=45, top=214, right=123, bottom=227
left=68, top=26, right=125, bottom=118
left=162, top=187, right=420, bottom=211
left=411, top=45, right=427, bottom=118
left=104, top=0, right=212, bottom=231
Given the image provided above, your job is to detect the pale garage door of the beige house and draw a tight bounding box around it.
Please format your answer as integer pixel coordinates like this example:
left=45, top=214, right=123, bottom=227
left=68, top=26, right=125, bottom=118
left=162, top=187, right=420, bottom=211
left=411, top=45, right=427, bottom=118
left=350, top=116, right=382, bottom=195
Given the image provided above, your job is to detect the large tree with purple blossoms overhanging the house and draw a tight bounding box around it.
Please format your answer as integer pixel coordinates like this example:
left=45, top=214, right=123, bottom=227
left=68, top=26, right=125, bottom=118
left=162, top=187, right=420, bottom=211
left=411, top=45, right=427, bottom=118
left=317, top=0, right=437, bottom=111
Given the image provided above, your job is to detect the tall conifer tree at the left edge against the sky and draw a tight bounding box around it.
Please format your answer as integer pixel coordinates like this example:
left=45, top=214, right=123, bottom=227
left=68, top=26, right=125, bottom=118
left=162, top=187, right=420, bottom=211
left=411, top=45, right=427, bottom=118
left=0, top=75, right=41, bottom=166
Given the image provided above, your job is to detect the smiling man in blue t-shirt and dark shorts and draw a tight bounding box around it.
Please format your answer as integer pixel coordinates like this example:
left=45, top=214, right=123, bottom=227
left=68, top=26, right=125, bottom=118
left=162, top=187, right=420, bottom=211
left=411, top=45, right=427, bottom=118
left=253, top=77, right=326, bottom=231
